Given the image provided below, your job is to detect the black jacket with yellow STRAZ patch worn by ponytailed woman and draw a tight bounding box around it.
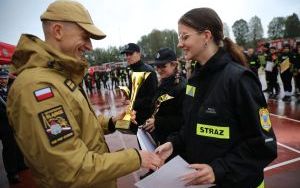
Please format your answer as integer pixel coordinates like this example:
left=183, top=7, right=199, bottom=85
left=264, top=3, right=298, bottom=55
left=170, top=49, right=277, bottom=188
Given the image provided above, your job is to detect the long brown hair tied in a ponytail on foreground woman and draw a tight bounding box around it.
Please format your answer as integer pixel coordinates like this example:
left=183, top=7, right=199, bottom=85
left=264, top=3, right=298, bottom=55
left=178, top=8, right=247, bottom=66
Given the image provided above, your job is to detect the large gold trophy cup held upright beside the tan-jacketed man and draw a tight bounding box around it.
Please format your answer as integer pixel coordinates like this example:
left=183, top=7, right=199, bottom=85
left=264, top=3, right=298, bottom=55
left=115, top=72, right=150, bottom=130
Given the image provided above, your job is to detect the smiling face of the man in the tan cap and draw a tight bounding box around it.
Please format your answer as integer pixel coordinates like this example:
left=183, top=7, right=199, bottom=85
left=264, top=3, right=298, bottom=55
left=60, top=23, right=92, bottom=60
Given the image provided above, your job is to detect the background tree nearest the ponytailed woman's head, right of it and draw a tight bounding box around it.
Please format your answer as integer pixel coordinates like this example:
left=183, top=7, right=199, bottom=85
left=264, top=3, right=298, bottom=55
left=232, top=19, right=249, bottom=46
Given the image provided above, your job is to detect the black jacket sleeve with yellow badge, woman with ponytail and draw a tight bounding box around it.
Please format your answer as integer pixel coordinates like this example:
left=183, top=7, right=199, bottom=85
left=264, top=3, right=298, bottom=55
left=210, top=71, right=277, bottom=184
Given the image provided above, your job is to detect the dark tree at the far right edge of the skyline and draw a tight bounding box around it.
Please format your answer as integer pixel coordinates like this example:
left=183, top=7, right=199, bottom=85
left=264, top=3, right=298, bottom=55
left=284, top=13, right=300, bottom=38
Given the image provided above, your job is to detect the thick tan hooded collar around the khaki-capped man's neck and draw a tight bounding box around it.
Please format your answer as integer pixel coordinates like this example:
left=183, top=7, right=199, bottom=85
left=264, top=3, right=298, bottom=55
left=12, top=34, right=88, bottom=85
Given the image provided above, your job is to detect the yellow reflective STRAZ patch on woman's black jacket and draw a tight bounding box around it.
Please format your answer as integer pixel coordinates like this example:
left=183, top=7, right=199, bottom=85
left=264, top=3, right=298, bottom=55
left=196, top=124, right=230, bottom=139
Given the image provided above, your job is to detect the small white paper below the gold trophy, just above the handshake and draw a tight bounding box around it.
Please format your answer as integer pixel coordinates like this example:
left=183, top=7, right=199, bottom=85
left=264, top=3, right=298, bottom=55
left=136, top=128, right=156, bottom=152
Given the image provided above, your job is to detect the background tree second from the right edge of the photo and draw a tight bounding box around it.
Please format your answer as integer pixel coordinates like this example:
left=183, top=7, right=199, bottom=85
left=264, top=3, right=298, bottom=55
left=268, top=17, right=285, bottom=39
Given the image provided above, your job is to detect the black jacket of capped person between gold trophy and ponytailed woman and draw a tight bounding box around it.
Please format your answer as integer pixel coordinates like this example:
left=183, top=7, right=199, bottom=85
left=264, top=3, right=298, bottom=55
left=153, top=75, right=187, bottom=144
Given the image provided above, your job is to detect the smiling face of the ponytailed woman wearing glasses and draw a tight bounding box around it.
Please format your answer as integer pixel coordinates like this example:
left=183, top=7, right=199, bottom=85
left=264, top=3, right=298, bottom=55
left=177, top=23, right=205, bottom=61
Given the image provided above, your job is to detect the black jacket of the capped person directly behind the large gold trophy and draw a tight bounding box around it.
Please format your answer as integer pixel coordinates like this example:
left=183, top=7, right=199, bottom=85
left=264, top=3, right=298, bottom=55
left=129, top=61, right=158, bottom=125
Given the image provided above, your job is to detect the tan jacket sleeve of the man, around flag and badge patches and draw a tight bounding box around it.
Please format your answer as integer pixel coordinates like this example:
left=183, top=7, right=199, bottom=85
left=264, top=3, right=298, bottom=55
left=8, top=84, right=141, bottom=187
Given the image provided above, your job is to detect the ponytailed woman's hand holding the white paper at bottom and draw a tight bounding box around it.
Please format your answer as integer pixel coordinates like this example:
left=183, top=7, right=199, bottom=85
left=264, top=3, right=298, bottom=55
left=181, top=164, right=215, bottom=186
